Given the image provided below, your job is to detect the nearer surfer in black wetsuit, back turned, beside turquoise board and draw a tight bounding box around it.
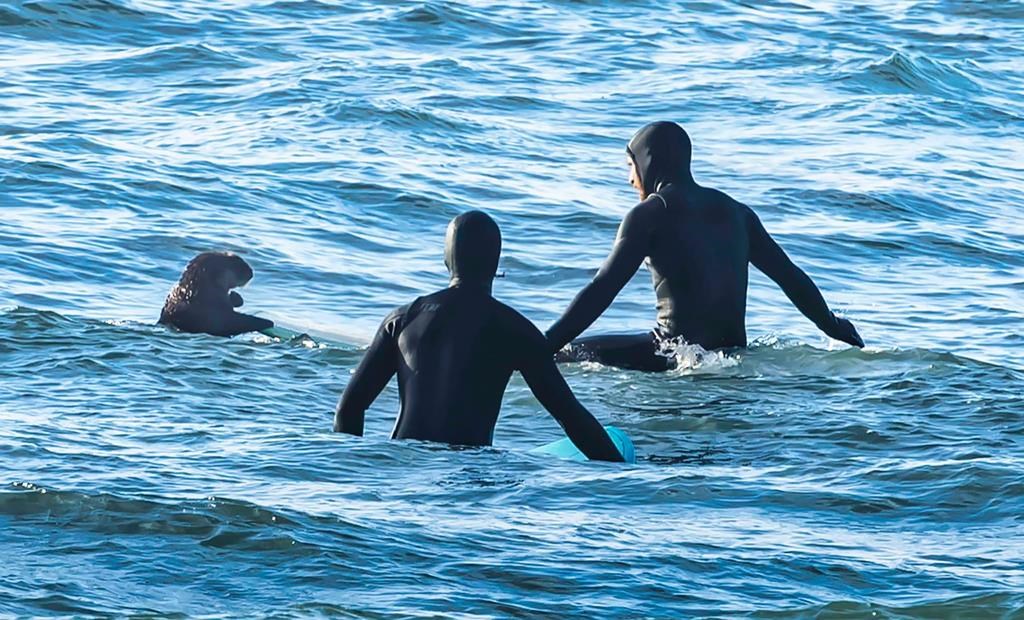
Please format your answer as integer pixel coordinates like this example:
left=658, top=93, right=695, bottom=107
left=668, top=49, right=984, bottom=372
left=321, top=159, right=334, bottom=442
left=334, top=211, right=623, bottom=461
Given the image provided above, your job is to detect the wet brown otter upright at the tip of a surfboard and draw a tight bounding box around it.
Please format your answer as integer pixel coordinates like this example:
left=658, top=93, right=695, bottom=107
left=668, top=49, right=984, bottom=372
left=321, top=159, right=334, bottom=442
left=159, top=252, right=273, bottom=336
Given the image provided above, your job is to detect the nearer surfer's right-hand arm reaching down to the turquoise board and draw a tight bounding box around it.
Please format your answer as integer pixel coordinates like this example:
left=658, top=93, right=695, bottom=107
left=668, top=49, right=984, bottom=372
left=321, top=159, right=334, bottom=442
left=519, top=325, right=623, bottom=462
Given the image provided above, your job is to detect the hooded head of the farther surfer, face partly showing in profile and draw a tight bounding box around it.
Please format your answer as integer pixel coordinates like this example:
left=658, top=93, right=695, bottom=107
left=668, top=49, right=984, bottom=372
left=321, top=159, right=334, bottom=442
left=626, top=121, right=693, bottom=200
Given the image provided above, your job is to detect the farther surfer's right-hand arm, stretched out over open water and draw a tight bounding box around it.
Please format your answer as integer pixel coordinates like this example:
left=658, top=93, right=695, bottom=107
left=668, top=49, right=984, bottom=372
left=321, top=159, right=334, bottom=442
left=746, top=207, right=864, bottom=346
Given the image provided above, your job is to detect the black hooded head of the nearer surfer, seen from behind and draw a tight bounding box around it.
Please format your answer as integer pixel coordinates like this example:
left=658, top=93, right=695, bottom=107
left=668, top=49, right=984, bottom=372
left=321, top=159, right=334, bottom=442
left=444, top=211, right=502, bottom=287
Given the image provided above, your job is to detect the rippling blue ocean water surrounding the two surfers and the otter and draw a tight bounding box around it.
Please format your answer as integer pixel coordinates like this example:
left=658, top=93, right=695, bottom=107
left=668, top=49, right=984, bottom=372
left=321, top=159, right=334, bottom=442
left=0, top=0, right=1024, bottom=618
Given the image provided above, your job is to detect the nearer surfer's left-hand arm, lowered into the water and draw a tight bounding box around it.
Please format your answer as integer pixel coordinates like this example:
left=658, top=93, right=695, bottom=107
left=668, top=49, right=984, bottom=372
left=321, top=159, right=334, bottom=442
left=334, top=311, right=398, bottom=437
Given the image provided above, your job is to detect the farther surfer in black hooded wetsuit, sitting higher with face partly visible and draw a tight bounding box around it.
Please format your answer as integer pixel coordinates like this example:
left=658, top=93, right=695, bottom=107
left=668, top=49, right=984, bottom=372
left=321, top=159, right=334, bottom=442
left=547, top=122, right=864, bottom=370
